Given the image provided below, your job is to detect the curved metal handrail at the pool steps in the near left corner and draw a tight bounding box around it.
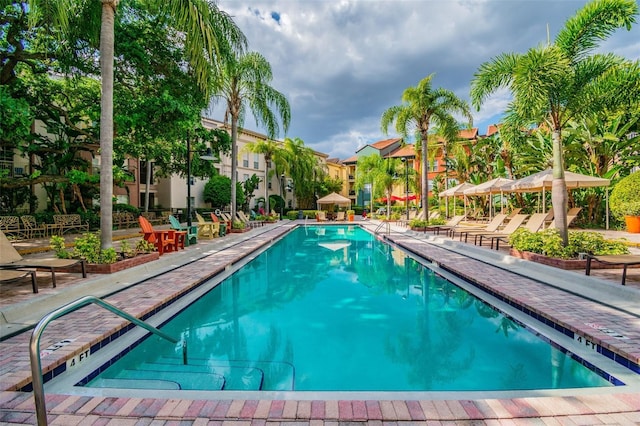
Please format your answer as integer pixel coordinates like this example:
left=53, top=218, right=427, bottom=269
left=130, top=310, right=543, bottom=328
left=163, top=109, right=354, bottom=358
left=29, top=296, right=187, bottom=426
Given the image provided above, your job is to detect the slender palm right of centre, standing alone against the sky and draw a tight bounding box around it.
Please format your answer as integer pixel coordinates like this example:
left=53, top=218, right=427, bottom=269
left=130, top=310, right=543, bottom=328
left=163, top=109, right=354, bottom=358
left=381, top=74, right=473, bottom=217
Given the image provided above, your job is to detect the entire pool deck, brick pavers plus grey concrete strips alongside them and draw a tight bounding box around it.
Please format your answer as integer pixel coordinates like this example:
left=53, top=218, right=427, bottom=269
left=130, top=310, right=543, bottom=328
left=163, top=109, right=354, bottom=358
left=0, top=222, right=640, bottom=425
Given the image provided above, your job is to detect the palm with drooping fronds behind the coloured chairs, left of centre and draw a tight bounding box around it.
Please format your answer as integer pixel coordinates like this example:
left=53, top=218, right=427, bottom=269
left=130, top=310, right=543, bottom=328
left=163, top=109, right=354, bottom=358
left=212, top=52, right=291, bottom=221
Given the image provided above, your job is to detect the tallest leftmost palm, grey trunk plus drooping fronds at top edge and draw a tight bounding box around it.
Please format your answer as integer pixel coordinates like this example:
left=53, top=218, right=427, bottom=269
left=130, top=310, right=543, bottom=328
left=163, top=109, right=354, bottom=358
left=18, top=0, right=246, bottom=249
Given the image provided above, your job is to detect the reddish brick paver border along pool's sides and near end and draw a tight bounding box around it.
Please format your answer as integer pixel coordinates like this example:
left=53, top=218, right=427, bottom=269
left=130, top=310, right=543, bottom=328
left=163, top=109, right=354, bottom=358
left=0, top=223, right=640, bottom=425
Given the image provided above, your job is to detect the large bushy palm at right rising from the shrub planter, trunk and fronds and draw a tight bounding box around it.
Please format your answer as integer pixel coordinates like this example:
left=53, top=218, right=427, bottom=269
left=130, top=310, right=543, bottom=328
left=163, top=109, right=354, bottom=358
left=471, top=0, right=638, bottom=245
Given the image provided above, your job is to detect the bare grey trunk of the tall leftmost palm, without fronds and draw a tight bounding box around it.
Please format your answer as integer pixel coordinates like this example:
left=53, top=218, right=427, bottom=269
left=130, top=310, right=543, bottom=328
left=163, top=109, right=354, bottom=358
left=100, top=0, right=118, bottom=250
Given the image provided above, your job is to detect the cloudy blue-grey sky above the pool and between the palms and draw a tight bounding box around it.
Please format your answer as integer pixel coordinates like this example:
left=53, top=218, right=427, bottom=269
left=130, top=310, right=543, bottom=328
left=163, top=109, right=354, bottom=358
left=213, top=0, right=640, bottom=159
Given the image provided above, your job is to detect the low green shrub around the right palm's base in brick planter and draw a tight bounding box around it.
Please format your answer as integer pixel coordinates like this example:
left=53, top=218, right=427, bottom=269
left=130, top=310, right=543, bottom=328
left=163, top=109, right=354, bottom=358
left=509, top=229, right=629, bottom=259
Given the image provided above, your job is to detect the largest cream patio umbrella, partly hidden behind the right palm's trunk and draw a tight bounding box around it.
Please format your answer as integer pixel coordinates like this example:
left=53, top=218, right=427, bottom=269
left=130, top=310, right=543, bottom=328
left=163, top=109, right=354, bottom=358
left=502, top=169, right=611, bottom=229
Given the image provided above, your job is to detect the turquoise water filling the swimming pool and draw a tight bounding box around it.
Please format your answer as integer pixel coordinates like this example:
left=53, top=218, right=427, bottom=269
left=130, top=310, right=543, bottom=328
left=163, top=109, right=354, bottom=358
left=88, top=226, right=611, bottom=391
